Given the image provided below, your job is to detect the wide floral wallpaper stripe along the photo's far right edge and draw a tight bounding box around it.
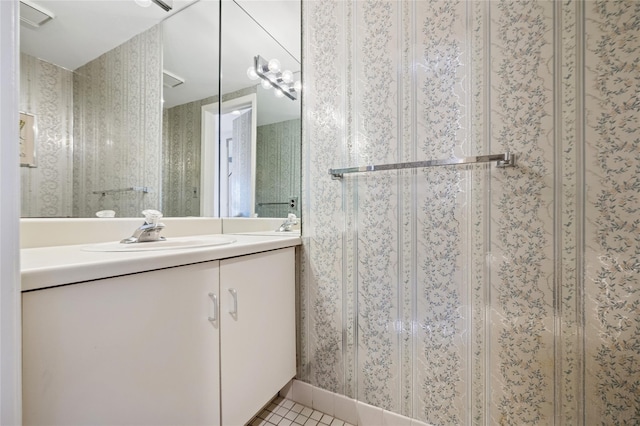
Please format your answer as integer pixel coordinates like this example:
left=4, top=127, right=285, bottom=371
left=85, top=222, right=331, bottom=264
left=583, top=1, right=640, bottom=424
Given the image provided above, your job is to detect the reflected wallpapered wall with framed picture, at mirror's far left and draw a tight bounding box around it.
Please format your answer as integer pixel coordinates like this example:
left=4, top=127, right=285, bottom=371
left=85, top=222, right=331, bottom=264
left=20, top=54, right=73, bottom=217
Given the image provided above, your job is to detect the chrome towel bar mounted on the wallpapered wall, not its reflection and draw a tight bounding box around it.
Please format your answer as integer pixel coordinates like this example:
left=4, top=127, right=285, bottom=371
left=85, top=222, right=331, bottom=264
left=329, top=151, right=516, bottom=179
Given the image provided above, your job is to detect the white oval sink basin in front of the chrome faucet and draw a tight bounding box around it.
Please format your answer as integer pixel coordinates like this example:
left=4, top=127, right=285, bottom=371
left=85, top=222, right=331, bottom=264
left=82, top=235, right=236, bottom=252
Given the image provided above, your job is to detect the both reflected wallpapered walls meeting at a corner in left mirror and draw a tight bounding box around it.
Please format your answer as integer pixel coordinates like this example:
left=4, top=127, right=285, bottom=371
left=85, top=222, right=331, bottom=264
left=20, top=26, right=161, bottom=217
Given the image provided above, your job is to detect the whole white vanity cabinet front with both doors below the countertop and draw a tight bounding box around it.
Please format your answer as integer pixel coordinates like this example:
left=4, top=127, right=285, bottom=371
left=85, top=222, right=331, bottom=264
left=23, top=247, right=295, bottom=426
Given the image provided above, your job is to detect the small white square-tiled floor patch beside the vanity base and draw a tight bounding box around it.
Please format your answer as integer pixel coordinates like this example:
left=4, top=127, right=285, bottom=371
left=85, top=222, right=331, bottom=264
left=249, top=396, right=353, bottom=426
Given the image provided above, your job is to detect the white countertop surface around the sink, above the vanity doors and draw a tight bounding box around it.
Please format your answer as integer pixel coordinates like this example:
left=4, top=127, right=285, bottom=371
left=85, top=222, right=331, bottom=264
left=20, top=233, right=301, bottom=291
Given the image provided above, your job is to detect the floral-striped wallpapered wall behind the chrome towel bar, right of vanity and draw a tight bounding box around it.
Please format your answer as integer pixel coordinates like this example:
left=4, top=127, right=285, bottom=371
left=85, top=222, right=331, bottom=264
left=298, top=0, right=640, bottom=425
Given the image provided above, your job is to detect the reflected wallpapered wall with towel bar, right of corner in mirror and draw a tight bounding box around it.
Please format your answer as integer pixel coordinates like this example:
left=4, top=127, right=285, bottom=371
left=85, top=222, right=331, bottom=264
left=73, top=25, right=162, bottom=217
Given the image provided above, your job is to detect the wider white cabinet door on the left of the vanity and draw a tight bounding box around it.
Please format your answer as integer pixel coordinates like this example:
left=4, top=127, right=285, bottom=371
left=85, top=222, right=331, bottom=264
left=23, top=262, right=220, bottom=425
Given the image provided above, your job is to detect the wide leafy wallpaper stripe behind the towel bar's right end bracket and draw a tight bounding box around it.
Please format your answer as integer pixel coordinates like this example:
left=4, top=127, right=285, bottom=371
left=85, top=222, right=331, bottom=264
left=488, top=2, right=555, bottom=424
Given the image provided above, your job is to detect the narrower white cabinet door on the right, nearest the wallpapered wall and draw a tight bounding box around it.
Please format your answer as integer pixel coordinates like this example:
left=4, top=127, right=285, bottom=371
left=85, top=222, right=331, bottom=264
left=220, top=248, right=296, bottom=425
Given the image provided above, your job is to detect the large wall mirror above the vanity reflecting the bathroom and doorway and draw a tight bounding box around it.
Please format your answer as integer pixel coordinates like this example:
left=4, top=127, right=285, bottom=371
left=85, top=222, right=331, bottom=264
left=20, top=0, right=301, bottom=217
